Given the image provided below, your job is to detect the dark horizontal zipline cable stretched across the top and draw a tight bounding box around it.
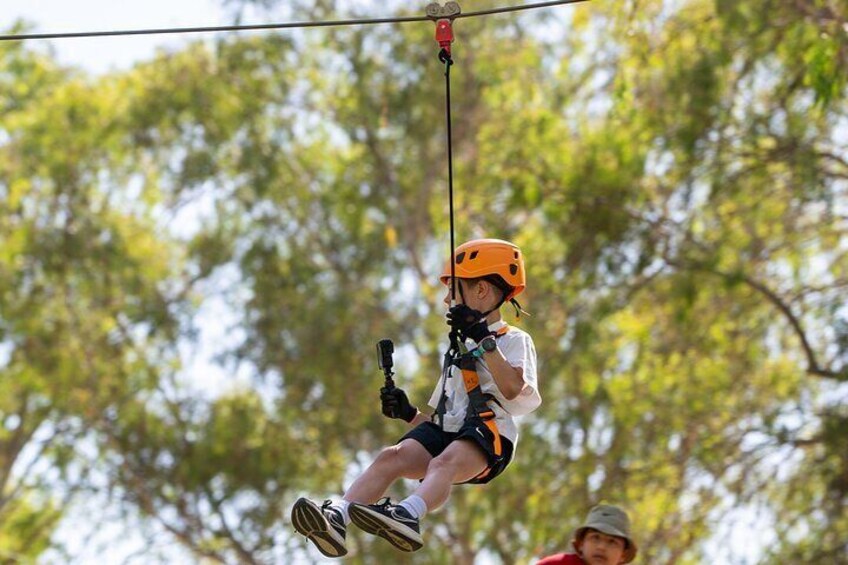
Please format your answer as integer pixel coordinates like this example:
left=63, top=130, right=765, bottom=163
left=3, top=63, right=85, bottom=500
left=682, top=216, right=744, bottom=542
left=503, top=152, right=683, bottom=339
left=0, top=0, right=589, bottom=41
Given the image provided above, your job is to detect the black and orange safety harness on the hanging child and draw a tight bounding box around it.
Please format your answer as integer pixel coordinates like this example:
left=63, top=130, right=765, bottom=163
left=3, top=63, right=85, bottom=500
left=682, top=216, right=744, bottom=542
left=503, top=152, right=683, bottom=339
left=434, top=325, right=510, bottom=480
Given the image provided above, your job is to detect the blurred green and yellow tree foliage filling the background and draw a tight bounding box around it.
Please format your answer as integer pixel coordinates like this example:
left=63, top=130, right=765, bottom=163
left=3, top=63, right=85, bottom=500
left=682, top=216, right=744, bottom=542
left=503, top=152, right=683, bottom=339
left=0, top=0, right=848, bottom=564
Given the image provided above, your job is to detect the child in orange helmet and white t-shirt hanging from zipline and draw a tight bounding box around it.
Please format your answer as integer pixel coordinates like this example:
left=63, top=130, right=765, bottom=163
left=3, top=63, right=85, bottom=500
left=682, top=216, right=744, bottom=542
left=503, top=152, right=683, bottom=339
left=291, top=239, right=542, bottom=557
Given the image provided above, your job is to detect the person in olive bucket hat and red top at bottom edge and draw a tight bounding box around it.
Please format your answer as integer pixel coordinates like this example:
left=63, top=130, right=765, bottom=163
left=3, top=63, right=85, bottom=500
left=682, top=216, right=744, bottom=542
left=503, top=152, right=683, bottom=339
left=537, top=504, right=638, bottom=565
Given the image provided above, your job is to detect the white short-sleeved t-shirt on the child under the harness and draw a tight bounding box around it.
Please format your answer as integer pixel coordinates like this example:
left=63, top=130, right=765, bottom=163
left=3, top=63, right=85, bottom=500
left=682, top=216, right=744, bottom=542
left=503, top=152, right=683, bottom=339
left=428, top=320, right=542, bottom=446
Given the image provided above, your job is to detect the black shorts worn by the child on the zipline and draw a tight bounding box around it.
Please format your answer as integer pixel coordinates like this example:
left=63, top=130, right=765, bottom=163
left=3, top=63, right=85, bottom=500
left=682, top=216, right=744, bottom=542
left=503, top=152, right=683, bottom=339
left=398, top=420, right=513, bottom=484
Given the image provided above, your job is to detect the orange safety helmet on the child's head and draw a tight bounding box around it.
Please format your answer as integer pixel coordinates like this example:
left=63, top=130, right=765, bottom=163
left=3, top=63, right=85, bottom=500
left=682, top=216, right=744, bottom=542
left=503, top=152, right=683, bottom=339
left=439, top=239, right=526, bottom=302
